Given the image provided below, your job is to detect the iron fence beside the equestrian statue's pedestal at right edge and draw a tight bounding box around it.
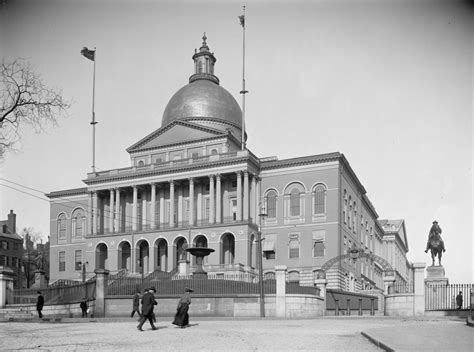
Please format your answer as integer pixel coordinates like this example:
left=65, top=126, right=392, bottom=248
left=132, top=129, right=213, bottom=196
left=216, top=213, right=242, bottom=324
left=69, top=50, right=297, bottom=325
left=425, top=284, right=474, bottom=311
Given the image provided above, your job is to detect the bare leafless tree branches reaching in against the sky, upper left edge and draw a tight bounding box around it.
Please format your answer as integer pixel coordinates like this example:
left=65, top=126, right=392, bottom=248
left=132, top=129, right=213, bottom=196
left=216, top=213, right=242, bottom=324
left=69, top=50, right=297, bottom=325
left=0, top=58, right=71, bottom=157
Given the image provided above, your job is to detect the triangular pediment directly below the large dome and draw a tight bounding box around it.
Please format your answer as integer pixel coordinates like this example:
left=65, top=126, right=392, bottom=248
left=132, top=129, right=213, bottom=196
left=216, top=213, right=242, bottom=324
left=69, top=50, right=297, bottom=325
left=127, top=121, right=228, bottom=153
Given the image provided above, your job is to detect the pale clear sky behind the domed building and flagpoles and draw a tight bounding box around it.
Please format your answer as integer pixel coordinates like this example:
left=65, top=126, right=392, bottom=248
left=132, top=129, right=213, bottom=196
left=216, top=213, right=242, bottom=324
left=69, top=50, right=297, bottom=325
left=0, top=0, right=474, bottom=283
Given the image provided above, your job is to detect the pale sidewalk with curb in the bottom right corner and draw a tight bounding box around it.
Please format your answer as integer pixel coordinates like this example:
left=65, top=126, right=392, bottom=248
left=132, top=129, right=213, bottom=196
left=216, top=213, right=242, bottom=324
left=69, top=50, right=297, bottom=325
left=362, top=319, right=474, bottom=352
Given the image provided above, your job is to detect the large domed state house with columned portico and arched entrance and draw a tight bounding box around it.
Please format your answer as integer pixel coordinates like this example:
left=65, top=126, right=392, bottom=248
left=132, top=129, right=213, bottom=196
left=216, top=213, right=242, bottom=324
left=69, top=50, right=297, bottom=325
left=47, top=36, right=409, bottom=291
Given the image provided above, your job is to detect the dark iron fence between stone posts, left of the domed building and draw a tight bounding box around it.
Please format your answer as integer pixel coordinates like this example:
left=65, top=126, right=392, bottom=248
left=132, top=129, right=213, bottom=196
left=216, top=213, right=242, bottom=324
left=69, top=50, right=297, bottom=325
left=13, top=279, right=96, bottom=305
